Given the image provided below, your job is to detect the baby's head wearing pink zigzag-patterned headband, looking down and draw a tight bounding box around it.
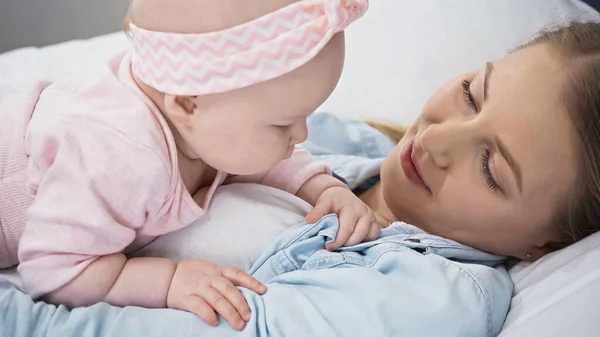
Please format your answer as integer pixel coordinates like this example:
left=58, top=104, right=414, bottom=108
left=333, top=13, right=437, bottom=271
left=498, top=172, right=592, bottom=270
left=127, top=0, right=367, bottom=175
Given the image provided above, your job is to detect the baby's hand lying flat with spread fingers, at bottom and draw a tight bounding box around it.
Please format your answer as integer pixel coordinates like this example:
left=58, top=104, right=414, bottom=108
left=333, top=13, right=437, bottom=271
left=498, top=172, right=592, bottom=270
left=167, top=260, right=267, bottom=330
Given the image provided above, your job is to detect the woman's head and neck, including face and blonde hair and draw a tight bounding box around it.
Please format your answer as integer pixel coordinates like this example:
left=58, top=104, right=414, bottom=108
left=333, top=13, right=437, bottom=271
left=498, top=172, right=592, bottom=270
left=308, top=23, right=600, bottom=260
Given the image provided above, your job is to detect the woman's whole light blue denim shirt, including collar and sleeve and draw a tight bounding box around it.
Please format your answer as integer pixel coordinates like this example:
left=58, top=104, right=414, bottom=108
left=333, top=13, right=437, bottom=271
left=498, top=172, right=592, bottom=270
left=0, top=115, right=512, bottom=337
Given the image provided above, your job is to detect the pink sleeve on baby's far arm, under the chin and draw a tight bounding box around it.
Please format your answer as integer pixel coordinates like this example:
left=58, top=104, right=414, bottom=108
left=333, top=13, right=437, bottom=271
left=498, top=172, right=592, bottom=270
left=225, top=147, right=331, bottom=195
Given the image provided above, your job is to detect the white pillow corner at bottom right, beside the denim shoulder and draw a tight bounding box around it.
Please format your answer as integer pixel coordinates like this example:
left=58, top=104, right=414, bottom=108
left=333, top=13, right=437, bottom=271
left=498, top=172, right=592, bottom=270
left=500, top=233, right=600, bottom=337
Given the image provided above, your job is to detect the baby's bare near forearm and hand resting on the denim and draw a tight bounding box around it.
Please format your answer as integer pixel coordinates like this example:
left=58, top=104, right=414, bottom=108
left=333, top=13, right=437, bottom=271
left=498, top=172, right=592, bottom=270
left=34, top=253, right=266, bottom=330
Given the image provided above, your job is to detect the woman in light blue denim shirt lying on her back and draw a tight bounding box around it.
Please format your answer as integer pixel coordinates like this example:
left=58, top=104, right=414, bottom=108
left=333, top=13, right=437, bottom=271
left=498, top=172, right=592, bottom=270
left=0, top=23, right=600, bottom=336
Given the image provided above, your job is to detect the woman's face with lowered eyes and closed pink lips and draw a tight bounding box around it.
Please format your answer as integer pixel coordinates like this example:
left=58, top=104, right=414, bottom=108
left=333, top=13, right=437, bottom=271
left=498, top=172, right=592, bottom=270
left=381, top=45, right=577, bottom=259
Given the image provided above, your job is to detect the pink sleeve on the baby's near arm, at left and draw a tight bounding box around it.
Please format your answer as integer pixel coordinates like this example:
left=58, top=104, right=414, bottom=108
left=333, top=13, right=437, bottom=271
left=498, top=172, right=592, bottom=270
left=18, top=118, right=171, bottom=298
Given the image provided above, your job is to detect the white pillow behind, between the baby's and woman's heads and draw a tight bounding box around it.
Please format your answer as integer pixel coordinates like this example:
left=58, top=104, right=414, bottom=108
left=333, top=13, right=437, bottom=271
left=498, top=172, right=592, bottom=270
left=320, top=0, right=591, bottom=124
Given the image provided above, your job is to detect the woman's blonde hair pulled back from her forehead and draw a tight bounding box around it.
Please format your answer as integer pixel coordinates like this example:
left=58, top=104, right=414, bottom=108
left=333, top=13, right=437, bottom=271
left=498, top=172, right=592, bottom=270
left=522, top=21, right=600, bottom=249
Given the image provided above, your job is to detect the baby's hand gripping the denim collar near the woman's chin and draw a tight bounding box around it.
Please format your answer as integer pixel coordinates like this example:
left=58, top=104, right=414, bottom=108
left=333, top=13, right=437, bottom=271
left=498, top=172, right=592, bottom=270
left=305, top=186, right=381, bottom=250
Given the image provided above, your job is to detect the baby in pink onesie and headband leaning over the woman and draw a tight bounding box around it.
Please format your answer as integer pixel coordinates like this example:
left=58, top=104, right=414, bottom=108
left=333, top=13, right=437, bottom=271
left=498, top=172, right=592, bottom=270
left=0, top=0, right=380, bottom=328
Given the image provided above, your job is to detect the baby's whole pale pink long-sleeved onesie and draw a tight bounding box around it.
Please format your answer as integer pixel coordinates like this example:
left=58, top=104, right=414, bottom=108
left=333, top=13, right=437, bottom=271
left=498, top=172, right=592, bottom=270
left=0, top=54, right=329, bottom=298
